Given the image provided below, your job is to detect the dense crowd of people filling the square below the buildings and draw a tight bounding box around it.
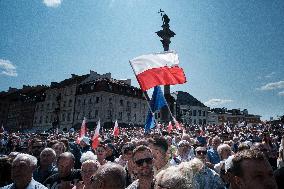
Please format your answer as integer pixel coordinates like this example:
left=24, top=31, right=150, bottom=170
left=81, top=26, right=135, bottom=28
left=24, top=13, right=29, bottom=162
left=0, top=124, right=284, bottom=189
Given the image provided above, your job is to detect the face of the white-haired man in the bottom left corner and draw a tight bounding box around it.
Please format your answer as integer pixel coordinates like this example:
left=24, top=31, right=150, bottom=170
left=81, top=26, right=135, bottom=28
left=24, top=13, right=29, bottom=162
left=11, top=160, right=33, bottom=185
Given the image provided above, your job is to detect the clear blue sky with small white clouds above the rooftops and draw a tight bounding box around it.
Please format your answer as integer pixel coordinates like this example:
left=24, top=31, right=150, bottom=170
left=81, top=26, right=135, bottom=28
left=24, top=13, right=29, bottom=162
left=0, top=0, right=284, bottom=119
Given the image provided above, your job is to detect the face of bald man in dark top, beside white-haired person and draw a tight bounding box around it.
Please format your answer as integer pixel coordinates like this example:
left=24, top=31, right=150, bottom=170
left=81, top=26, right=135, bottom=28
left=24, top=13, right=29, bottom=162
left=57, top=157, right=74, bottom=178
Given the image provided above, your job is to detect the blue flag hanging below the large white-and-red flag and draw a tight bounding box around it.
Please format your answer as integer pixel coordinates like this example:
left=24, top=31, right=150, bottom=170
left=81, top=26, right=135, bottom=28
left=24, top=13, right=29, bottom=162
left=144, top=86, right=167, bottom=133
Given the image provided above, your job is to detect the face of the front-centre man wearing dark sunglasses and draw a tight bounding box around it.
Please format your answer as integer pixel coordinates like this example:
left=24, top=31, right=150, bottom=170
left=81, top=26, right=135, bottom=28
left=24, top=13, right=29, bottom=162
left=133, top=150, right=154, bottom=178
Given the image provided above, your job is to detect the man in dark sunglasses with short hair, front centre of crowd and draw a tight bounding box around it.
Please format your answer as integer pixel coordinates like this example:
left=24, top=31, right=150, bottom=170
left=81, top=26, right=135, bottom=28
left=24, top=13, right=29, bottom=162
left=127, top=145, right=154, bottom=189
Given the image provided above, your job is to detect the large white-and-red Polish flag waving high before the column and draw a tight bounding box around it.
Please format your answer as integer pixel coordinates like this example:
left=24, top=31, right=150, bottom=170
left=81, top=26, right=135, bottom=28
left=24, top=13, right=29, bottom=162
left=130, top=51, right=186, bottom=91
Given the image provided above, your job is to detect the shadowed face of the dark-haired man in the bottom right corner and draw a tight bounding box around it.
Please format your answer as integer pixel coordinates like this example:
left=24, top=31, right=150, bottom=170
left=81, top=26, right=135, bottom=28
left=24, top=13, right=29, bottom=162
left=239, top=160, right=277, bottom=189
